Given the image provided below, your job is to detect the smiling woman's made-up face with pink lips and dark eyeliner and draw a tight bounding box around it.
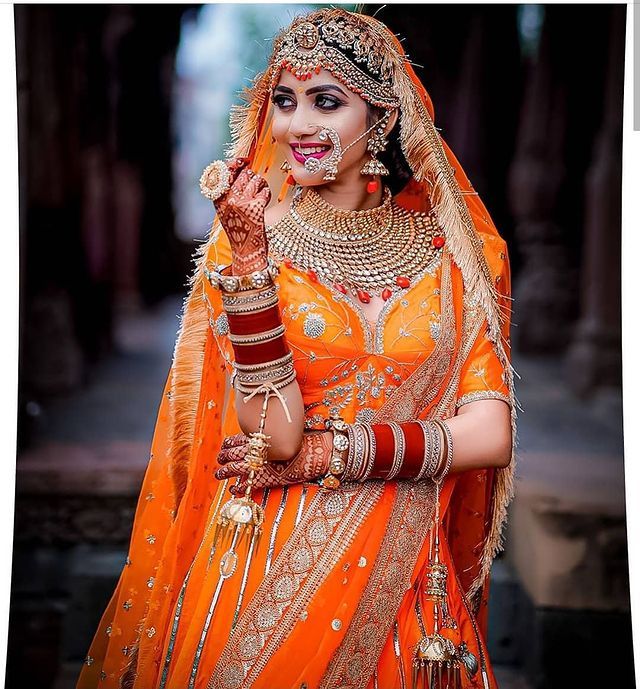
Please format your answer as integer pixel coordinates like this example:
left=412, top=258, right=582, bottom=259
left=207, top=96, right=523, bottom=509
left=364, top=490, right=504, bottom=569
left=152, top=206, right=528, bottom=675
left=272, top=69, right=370, bottom=186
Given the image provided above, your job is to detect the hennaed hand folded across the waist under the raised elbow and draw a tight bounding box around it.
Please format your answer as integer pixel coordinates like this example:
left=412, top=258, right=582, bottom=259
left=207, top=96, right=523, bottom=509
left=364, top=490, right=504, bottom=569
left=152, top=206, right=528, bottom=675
left=215, top=431, right=333, bottom=495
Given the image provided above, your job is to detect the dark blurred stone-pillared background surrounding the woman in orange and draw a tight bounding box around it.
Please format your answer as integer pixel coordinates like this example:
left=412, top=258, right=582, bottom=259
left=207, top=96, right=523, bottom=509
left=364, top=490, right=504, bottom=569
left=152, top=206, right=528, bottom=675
left=6, top=4, right=634, bottom=689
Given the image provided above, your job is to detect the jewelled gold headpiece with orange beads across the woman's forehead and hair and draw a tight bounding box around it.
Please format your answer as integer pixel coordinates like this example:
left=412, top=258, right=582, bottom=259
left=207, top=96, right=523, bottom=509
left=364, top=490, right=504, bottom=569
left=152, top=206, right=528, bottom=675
left=270, top=10, right=402, bottom=108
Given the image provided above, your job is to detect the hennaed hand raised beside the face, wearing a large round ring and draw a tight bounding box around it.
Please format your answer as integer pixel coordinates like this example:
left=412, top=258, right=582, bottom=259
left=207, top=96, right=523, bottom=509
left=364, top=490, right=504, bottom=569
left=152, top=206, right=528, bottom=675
left=209, top=158, right=271, bottom=275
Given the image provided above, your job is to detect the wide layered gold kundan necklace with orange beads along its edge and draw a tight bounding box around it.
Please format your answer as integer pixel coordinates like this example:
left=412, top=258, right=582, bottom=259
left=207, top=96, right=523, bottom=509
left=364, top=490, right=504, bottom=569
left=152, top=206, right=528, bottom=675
left=266, top=187, right=445, bottom=304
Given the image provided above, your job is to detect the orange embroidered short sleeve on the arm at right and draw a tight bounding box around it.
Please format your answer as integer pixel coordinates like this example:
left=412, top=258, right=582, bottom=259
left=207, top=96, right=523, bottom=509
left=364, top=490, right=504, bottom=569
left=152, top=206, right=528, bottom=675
left=456, top=237, right=512, bottom=409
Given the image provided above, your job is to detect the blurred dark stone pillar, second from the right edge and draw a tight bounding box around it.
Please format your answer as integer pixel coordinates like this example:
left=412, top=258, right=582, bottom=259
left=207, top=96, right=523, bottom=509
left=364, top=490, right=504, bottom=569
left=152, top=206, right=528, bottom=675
left=509, top=6, right=575, bottom=353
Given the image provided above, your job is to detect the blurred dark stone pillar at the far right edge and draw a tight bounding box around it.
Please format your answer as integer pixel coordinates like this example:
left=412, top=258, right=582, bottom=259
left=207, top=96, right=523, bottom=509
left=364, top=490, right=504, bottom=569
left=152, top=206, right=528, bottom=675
left=566, top=5, right=626, bottom=395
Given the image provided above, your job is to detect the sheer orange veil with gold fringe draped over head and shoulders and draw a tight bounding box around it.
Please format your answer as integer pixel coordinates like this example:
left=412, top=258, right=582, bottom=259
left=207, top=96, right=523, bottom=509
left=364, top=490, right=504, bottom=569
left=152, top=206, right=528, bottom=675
left=77, top=9, right=517, bottom=689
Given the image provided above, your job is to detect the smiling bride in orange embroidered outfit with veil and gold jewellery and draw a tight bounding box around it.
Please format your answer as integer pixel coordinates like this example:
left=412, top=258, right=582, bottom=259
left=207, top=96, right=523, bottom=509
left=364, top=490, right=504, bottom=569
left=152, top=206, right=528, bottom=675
left=77, top=8, right=516, bottom=689
